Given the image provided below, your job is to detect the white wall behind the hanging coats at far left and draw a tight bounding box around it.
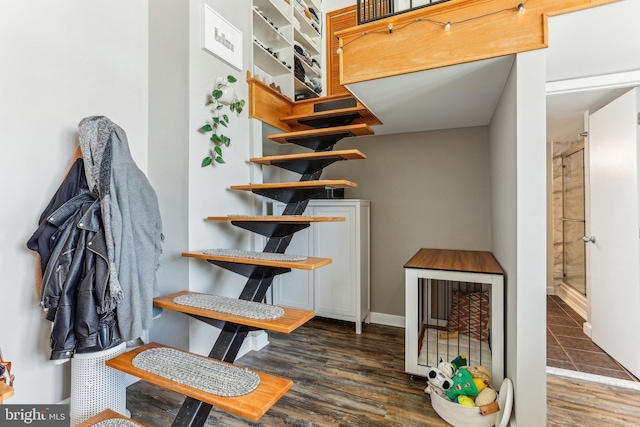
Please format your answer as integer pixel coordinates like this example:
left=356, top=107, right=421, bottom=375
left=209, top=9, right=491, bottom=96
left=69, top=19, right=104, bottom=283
left=0, top=0, right=148, bottom=404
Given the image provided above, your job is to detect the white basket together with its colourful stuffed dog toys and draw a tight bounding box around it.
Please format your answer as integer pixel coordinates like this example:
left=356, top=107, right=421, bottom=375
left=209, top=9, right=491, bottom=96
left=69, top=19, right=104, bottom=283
left=425, top=356, right=513, bottom=427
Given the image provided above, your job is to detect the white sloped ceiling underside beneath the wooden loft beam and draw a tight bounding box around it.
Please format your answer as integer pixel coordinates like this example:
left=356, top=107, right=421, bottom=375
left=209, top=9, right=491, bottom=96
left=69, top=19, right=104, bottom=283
left=347, top=56, right=513, bottom=135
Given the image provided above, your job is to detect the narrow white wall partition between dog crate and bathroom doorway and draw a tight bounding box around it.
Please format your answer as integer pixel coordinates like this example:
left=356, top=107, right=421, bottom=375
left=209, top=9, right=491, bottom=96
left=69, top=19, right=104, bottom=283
left=490, top=50, right=546, bottom=427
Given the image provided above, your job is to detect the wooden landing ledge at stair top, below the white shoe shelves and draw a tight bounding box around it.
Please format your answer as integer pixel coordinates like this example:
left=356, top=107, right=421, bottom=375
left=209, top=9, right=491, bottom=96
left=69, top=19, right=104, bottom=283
left=247, top=71, right=381, bottom=132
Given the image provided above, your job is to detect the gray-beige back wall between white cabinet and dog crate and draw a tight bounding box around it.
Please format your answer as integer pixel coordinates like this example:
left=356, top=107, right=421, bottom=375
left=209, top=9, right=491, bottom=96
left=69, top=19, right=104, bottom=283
left=322, top=126, right=491, bottom=316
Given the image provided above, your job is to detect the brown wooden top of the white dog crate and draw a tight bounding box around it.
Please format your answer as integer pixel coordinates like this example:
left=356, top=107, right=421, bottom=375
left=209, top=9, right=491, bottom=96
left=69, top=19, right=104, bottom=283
left=404, top=248, right=504, bottom=274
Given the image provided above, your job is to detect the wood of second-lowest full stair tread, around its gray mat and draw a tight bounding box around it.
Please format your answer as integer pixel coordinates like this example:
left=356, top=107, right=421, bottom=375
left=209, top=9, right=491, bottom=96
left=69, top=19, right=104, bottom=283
left=153, top=291, right=315, bottom=334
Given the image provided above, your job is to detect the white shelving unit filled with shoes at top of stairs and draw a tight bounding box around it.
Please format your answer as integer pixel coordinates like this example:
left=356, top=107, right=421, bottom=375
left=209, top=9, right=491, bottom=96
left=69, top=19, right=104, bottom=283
left=251, top=0, right=322, bottom=100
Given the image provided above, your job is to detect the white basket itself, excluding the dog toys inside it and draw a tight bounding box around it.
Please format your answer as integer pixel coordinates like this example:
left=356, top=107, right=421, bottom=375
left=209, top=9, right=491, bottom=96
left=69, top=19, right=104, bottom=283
left=431, top=378, right=513, bottom=427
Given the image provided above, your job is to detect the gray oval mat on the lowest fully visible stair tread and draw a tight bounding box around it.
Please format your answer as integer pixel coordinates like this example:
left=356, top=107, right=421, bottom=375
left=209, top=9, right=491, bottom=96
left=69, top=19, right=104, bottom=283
left=131, top=348, right=260, bottom=397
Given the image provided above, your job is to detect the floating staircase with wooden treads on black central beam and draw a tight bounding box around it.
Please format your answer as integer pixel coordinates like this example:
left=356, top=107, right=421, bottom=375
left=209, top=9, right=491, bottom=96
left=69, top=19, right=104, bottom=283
left=106, top=96, right=373, bottom=426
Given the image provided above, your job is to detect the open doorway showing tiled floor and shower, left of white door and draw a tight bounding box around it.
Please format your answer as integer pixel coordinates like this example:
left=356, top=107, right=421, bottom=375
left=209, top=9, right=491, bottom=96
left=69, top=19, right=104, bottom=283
left=547, top=82, right=638, bottom=381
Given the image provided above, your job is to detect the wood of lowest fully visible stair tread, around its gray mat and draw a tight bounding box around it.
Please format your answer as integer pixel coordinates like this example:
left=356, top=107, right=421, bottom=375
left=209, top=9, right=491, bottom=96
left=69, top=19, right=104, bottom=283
left=105, top=343, right=293, bottom=421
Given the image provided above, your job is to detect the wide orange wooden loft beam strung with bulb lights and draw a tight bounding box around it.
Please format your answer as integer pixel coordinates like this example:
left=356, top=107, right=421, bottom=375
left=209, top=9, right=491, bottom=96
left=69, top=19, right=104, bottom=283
left=335, top=0, right=617, bottom=85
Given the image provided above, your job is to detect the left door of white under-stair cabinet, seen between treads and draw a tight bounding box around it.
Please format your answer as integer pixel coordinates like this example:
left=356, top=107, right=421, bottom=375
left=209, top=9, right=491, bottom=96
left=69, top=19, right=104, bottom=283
left=273, top=204, right=313, bottom=311
